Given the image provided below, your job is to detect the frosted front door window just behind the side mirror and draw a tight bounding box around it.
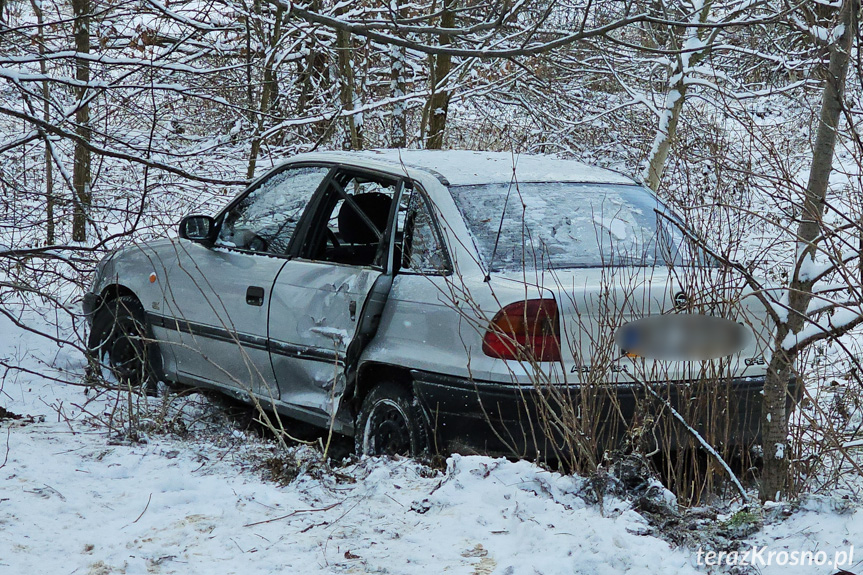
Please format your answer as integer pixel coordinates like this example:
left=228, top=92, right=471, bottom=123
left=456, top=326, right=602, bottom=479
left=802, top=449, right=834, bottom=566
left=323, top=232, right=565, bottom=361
left=216, top=167, right=330, bottom=255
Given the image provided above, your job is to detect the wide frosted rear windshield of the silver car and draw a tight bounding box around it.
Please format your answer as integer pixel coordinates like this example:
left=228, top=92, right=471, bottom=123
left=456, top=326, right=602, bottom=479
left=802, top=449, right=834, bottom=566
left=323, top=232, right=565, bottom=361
left=450, top=182, right=708, bottom=272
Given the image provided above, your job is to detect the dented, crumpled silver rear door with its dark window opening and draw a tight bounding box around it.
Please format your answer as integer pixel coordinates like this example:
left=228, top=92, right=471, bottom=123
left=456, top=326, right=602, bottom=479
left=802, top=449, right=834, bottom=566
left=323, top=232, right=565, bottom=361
left=269, top=169, right=404, bottom=426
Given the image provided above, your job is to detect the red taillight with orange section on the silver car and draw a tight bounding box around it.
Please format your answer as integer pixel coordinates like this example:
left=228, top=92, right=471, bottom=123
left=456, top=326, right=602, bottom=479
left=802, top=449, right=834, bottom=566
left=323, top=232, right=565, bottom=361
left=482, top=299, right=560, bottom=361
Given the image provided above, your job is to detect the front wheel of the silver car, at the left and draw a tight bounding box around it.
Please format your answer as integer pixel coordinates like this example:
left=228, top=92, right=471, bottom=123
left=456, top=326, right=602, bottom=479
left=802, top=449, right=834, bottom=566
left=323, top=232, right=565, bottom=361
left=87, top=296, right=161, bottom=395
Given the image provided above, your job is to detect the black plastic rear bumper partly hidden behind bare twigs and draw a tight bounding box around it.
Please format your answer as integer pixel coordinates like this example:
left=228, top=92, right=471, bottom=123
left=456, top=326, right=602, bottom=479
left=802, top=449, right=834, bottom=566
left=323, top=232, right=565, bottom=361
left=412, top=371, right=799, bottom=458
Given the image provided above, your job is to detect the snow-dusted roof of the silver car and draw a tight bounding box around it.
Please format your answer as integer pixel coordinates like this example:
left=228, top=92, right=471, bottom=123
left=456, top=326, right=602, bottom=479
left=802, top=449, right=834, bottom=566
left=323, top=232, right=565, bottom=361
left=290, top=149, right=635, bottom=186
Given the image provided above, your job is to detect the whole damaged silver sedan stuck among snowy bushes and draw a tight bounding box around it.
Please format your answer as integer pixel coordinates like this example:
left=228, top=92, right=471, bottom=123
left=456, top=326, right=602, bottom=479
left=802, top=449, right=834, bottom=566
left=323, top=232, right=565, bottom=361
left=84, top=150, right=780, bottom=457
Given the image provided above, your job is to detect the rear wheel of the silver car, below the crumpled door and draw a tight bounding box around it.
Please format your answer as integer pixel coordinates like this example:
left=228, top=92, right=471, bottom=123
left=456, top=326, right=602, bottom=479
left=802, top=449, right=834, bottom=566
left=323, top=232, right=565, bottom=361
left=354, top=383, right=428, bottom=457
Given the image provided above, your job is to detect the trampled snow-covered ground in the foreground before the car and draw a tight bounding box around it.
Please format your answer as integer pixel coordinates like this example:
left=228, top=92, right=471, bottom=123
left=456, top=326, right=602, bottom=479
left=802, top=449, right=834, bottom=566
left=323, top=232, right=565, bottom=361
left=0, top=414, right=692, bottom=574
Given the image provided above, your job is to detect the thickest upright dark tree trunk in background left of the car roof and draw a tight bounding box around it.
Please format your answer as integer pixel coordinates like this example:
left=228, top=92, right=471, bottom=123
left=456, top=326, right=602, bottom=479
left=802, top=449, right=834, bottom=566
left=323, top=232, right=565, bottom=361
left=72, top=0, right=91, bottom=242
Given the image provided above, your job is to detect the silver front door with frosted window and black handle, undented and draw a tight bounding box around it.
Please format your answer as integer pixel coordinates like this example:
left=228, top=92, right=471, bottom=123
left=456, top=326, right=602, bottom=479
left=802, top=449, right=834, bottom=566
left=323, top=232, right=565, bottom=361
left=155, top=166, right=330, bottom=399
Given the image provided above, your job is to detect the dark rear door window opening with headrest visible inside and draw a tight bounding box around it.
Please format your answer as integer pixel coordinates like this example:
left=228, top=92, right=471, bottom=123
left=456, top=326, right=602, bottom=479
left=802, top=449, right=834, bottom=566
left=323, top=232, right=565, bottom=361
left=303, top=171, right=398, bottom=266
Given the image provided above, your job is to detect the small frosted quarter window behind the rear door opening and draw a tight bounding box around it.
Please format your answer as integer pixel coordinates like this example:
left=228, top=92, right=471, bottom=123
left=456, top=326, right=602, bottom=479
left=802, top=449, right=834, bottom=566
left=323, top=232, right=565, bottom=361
left=399, top=189, right=449, bottom=275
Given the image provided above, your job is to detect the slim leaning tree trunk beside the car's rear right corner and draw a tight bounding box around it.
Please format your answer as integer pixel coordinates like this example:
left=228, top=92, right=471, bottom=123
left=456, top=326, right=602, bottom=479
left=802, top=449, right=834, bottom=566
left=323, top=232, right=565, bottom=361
left=761, top=0, right=859, bottom=501
